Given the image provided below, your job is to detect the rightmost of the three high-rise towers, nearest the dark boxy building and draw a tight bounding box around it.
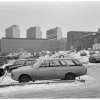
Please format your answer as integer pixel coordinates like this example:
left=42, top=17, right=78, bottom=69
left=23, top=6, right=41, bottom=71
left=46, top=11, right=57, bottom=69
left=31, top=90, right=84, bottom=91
left=46, top=27, right=62, bottom=40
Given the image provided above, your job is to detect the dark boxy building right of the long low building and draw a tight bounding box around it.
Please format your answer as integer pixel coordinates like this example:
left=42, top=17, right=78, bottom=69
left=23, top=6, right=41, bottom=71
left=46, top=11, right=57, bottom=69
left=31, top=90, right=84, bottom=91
left=67, top=31, right=96, bottom=49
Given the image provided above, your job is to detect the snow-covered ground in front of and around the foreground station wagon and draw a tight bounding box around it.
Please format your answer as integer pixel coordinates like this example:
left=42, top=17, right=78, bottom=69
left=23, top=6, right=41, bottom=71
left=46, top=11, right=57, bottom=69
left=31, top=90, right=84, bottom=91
left=0, top=50, right=100, bottom=98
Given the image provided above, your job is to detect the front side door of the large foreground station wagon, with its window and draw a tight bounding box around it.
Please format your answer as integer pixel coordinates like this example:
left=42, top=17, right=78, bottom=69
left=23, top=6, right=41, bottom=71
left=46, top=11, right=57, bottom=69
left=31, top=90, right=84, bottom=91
left=35, top=60, right=55, bottom=79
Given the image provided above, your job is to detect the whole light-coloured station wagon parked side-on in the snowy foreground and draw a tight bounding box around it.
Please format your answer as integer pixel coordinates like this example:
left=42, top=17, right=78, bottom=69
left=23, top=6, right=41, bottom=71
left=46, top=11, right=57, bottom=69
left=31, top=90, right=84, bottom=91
left=11, top=58, right=87, bottom=83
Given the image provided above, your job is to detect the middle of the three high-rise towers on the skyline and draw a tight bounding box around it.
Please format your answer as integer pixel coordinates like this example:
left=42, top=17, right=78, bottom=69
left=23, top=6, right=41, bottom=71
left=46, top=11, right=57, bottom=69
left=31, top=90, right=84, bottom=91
left=26, top=26, right=42, bottom=39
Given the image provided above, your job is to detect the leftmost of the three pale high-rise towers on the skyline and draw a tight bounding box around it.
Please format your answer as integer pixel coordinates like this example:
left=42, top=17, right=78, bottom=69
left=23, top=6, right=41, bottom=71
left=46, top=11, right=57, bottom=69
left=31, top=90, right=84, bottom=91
left=5, top=25, right=20, bottom=38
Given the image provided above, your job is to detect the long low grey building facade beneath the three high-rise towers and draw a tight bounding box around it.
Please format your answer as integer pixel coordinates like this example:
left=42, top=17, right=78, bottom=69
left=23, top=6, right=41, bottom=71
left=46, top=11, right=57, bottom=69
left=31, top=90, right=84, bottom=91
left=0, top=38, right=66, bottom=53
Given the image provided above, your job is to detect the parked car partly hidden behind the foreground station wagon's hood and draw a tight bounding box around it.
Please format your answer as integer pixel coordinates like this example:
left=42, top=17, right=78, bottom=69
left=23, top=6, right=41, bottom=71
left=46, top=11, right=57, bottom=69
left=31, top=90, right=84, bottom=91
left=2, top=59, right=36, bottom=72
